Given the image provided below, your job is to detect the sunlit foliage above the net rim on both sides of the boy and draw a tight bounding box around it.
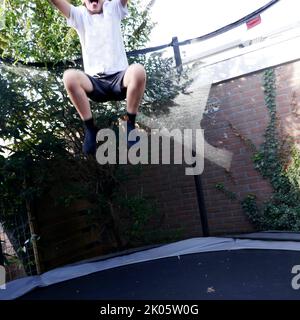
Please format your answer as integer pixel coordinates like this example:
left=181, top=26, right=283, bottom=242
left=0, top=0, right=154, bottom=63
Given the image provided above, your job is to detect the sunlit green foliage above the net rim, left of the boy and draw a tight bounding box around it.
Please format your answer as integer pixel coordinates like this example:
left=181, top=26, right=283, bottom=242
left=0, top=0, right=80, bottom=63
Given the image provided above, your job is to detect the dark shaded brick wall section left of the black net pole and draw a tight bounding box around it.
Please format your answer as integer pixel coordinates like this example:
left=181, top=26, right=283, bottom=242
left=125, top=159, right=202, bottom=241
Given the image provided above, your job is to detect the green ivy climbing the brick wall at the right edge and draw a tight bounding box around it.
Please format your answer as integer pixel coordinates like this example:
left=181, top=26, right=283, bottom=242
left=242, top=69, right=300, bottom=231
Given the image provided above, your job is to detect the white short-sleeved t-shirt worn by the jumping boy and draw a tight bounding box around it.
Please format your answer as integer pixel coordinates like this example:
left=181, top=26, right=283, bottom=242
left=67, top=0, right=128, bottom=76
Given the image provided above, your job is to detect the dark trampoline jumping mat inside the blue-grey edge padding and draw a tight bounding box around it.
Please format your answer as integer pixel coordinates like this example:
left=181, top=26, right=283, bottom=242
left=20, top=249, right=300, bottom=300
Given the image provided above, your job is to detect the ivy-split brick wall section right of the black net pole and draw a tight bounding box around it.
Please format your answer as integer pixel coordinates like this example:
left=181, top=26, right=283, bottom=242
left=201, top=61, right=300, bottom=234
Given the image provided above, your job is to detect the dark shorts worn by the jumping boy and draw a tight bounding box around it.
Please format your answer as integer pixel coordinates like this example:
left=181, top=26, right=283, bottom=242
left=87, top=70, right=127, bottom=102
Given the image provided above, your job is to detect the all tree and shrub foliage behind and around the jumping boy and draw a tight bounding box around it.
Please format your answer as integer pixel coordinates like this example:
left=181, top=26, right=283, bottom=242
left=0, top=0, right=190, bottom=272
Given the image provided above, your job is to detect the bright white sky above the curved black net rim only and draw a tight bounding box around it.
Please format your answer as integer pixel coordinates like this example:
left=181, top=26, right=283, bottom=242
left=151, top=0, right=268, bottom=45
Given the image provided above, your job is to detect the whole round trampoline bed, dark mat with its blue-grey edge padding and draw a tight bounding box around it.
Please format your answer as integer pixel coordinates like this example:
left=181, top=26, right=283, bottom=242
left=0, top=232, right=300, bottom=300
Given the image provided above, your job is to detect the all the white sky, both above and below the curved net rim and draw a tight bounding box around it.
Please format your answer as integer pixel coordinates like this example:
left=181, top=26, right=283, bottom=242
left=144, top=0, right=300, bottom=46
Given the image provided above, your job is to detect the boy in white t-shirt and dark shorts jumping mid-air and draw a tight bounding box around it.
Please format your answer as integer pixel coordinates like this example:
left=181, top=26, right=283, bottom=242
left=50, top=0, right=146, bottom=155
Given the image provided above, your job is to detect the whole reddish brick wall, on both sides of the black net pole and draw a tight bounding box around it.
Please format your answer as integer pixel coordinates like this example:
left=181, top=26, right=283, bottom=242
left=128, top=61, right=300, bottom=237
